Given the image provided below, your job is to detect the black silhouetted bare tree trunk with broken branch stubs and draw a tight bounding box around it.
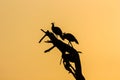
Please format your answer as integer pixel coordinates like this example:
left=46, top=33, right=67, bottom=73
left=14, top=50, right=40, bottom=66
left=39, top=29, right=85, bottom=80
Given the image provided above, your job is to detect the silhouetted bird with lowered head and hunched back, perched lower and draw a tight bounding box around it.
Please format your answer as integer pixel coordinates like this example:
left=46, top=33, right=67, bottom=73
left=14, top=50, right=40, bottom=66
left=62, top=33, right=79, bottom=47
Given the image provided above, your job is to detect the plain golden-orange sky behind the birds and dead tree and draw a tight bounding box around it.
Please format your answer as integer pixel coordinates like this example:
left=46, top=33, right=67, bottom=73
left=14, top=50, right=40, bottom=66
left=0, top=0, right=120, bottom=80
